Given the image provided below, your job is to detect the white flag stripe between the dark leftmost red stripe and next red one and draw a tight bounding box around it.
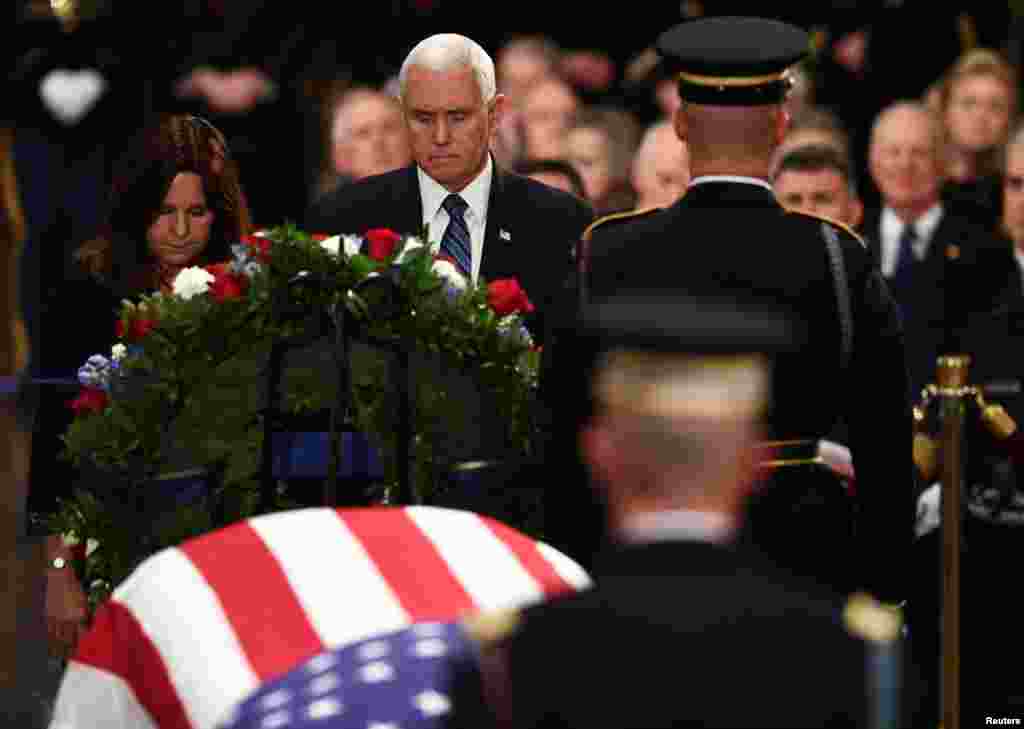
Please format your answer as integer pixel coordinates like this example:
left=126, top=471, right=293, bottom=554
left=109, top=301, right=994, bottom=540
left=115, top=549, right=259, bottom=729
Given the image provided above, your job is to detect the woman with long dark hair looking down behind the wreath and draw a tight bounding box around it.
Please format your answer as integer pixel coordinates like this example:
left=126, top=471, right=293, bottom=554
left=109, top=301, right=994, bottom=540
left=23, top=115, right=250, bottom=655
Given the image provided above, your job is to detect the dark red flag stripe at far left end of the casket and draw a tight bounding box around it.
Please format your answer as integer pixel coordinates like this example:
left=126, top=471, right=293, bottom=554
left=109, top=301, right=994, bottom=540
left=74, top=600, right=193, bottom=729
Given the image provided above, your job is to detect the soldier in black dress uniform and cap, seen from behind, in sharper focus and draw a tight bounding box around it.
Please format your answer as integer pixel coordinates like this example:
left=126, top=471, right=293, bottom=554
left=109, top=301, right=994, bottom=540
left=584, top=17, right=915, bottom=601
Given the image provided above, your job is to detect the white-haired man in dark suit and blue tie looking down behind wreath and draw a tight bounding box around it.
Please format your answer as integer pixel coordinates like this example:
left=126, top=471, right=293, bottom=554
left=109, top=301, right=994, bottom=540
left=306, top=34, right=592, bottom=334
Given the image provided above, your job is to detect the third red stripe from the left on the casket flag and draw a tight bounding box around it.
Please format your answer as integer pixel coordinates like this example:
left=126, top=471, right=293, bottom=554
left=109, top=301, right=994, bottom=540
left=336, top=507, right=476, bottom=623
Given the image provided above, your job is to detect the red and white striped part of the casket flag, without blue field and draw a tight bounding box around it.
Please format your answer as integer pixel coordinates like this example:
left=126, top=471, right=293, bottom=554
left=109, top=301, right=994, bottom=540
left=50, top=506, right=590, bottom=729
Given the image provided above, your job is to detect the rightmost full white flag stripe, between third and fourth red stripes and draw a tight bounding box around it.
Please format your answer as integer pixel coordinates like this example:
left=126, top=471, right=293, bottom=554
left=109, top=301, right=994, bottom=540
left=407, top=506, right=544, bottom=610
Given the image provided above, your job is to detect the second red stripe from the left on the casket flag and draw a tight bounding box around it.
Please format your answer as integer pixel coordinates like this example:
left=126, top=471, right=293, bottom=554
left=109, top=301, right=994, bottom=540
left=180, top=522, right=321, bottom=681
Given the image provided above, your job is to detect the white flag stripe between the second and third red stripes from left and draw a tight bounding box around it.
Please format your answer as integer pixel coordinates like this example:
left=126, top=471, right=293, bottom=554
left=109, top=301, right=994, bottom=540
left=249, top=509, right=409, bottom=648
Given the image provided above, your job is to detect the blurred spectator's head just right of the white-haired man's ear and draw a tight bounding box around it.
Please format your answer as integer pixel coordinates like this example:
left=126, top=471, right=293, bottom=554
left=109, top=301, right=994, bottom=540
left=520, top=78, right=582, bottom=160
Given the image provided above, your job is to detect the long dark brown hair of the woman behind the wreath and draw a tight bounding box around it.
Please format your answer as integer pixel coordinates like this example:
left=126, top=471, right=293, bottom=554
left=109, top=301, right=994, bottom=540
left=76, top=115, right=251, bottom=294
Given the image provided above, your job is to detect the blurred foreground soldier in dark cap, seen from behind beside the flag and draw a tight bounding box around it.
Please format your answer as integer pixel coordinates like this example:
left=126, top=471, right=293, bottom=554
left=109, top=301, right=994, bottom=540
left=447, top=293, right=924, bottom=729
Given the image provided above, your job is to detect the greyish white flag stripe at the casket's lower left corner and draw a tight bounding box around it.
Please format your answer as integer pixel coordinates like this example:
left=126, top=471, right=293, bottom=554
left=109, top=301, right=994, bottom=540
left=49, top=660, right=157, bottom=729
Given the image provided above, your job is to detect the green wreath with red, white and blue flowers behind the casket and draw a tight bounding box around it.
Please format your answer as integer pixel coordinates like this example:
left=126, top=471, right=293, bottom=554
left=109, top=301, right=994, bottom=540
left=50, top=225, right=539, bottom=598
